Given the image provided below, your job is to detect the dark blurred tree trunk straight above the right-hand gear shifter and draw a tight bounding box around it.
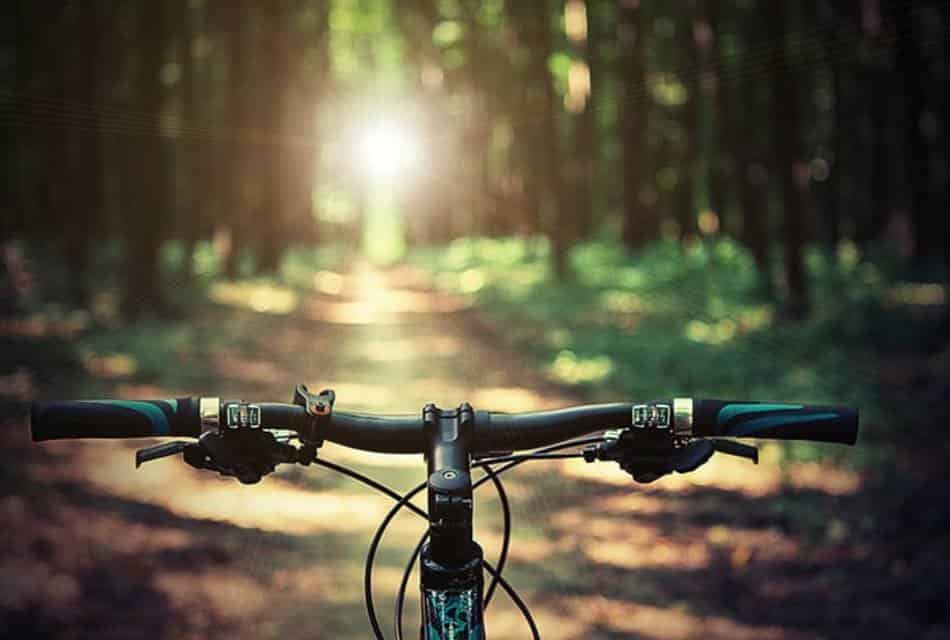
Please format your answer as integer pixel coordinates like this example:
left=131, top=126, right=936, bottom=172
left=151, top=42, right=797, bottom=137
left=618, top=0, right=660, bottom=251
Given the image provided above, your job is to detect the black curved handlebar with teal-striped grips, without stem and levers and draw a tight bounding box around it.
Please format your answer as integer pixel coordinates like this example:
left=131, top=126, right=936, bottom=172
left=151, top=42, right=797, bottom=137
left=30, top=398, right=858, bottom=453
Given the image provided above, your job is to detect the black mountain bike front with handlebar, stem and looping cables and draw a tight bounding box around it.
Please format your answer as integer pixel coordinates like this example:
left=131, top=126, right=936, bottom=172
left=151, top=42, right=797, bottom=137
left=30, top=385, right=858, bottom=640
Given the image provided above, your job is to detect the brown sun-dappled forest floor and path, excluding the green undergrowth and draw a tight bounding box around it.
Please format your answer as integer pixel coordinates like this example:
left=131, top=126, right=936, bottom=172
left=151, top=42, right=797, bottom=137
left=0, top=266, right=950, bottom=640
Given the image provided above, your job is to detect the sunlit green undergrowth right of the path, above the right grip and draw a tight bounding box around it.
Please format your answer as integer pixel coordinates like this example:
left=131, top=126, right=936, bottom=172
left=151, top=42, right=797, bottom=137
left=414, top=238, right=913, bottom=468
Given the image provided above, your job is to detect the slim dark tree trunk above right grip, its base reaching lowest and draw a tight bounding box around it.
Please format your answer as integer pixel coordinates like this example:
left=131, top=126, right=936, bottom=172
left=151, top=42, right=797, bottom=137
left=769, top=2, right=808, bottom=318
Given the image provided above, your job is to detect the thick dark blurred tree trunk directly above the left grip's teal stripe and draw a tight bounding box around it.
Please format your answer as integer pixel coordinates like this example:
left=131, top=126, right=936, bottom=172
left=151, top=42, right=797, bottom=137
left=124, top=2, right=169, bottom=315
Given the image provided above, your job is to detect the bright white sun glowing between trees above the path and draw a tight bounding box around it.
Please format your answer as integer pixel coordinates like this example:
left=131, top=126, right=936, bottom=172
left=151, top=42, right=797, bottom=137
left=357, top=121, right=422, bottom=181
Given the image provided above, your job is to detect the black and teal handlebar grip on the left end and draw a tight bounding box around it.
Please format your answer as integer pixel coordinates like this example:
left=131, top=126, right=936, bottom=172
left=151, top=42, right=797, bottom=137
left=30, top=398, right=201, bottom=442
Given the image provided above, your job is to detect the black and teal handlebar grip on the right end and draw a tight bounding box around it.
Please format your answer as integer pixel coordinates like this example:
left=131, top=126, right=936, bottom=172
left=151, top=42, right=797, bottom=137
left=693, top=400, right=858, bottom=444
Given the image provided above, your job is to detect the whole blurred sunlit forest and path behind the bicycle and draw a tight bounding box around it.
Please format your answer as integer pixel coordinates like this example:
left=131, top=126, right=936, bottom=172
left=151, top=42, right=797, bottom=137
left=0, top=0, right=950, bottom=640
